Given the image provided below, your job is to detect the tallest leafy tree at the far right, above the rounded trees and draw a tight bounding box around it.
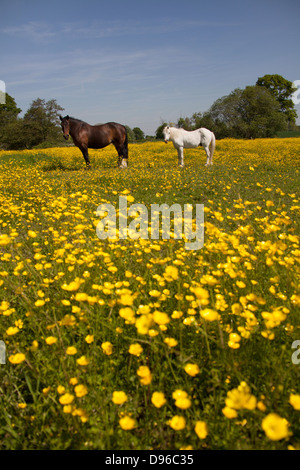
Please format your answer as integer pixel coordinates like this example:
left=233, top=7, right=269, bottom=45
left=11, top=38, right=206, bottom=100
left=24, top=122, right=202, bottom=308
left=256, top=74, right=297, bottom=124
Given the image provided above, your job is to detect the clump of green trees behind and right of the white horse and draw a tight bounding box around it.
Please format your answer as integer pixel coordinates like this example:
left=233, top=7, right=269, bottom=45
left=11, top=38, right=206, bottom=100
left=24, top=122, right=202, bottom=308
left=156, top=75, right=299, bottom=139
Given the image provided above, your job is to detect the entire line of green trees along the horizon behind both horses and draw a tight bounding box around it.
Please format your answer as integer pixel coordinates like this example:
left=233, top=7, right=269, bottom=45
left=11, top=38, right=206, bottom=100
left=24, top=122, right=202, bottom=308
left=0, top=75, right=298, bottom=150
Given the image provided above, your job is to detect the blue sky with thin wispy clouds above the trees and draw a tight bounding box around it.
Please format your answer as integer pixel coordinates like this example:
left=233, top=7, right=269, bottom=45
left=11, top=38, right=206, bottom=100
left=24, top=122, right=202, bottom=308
left=0, top=0, right=300, bottom=135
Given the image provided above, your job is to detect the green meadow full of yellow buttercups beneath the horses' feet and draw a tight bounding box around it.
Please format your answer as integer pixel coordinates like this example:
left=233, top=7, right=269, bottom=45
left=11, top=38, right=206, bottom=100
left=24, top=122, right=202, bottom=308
left=0, top=138, right=300, bottom=450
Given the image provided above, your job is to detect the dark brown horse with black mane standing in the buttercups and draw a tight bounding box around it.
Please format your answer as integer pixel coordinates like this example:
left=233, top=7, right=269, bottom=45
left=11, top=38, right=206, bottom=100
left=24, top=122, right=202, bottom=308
left=59, top=116, right=128, bottom=168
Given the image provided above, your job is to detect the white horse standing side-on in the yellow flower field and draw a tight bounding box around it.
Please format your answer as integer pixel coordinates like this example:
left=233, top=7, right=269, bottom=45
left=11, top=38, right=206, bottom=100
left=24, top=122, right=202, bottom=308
left=163, top=126, right=216, bottom=166
